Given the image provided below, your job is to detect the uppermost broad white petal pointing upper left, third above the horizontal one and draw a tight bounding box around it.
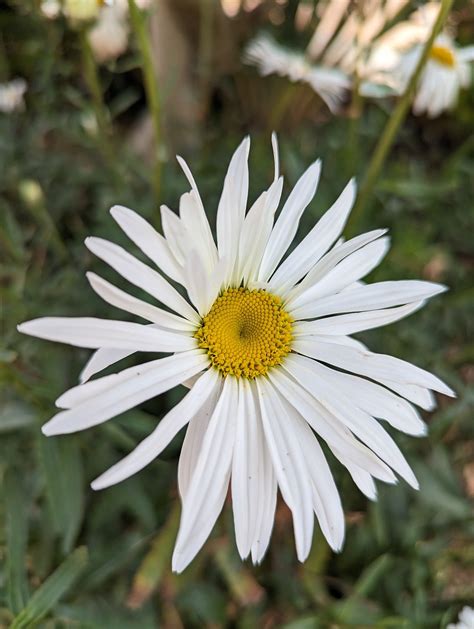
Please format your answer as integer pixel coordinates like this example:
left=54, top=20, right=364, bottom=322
left=110, top=205, right=183, bottom=284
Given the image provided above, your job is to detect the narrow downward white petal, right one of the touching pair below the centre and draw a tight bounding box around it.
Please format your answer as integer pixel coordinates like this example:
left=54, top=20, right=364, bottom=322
left=250, top=382, right=278, bottom=564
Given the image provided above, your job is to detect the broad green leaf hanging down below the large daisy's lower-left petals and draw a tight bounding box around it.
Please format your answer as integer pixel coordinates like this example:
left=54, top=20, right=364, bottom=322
left=38, top=434, right=84, bottom=553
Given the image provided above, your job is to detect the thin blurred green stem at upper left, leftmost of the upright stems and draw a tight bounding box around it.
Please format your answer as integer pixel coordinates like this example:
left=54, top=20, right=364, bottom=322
left=79, top=28, right=117, bottom=178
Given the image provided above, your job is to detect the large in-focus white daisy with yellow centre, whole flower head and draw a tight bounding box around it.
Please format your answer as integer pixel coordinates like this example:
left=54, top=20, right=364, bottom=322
left=19, top=138, right=454, bottom=572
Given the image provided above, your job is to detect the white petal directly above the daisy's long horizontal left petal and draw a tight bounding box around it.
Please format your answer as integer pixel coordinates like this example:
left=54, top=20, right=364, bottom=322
left=86, top=272, right=196, bottom=332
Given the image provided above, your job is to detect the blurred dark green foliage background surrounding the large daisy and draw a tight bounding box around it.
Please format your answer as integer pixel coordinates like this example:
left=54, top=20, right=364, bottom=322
left=0, top=0, right=474, bottom=629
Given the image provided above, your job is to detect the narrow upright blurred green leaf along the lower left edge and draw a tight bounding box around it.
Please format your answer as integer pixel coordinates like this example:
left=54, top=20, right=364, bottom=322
left=4, top=470, right=28, bottom=614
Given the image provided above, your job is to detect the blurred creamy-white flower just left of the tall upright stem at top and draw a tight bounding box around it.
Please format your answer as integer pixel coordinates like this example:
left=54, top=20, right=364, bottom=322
left=89, top=4, right=129, bottom=63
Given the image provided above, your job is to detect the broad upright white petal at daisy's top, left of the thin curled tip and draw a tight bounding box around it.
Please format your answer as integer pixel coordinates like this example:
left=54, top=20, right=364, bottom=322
left=217, top=137, right=250, bottom=280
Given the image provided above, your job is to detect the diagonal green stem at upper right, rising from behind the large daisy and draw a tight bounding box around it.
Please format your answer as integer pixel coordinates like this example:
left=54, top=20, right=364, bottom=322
left=351, top=0, right=453, bottom=231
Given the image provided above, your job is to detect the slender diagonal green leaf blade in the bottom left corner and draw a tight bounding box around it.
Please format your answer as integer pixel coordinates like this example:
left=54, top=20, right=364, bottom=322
left=10, top=546, right=87, bottom=629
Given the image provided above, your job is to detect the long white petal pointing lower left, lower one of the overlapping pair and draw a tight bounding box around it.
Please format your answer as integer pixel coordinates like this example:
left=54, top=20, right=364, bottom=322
left=42, top=350, right=208, bottom=436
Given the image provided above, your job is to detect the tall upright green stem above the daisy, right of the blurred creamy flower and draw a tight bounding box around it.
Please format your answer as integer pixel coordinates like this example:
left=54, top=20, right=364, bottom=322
left=128, top=0, right=161, bottom=201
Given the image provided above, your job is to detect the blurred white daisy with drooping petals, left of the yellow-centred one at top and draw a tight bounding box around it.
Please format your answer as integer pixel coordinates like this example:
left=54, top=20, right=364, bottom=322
left=244, top=35, right=351, bottom=112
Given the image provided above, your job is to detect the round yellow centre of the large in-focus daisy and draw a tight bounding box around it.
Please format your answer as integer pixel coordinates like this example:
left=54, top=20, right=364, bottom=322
left=195, top=288, right=292, bottom=378
